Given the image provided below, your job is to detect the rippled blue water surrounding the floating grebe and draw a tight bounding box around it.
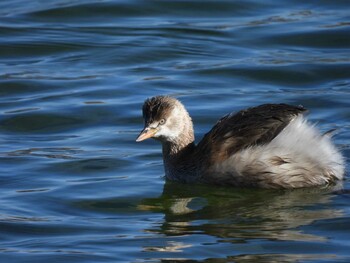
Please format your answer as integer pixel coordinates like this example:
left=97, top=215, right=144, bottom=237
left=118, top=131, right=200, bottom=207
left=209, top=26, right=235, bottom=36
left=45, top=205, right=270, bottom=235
left=0, top=0, right=350, bottom=262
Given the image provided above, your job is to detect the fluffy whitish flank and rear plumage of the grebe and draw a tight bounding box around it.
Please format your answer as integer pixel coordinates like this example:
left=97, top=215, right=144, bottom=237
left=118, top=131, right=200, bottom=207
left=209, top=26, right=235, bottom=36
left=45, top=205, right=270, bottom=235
left=212, top=116, right=344, bottom=188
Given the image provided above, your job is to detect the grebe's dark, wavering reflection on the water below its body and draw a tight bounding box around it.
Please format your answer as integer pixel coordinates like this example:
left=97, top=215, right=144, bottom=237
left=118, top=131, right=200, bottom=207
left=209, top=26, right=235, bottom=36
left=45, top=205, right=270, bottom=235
left=139, top=182, right=343, bottom=243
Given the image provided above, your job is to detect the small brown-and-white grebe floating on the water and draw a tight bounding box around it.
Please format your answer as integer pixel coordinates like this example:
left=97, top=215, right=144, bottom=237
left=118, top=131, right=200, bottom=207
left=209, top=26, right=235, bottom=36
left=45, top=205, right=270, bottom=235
left=136, top=96, right=344, bottom=188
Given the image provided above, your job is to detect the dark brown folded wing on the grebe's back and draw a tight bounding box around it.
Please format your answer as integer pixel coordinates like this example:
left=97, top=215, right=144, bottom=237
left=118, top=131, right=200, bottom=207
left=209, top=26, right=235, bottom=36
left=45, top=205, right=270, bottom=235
left=196, top=104, right=306, bottom=165
